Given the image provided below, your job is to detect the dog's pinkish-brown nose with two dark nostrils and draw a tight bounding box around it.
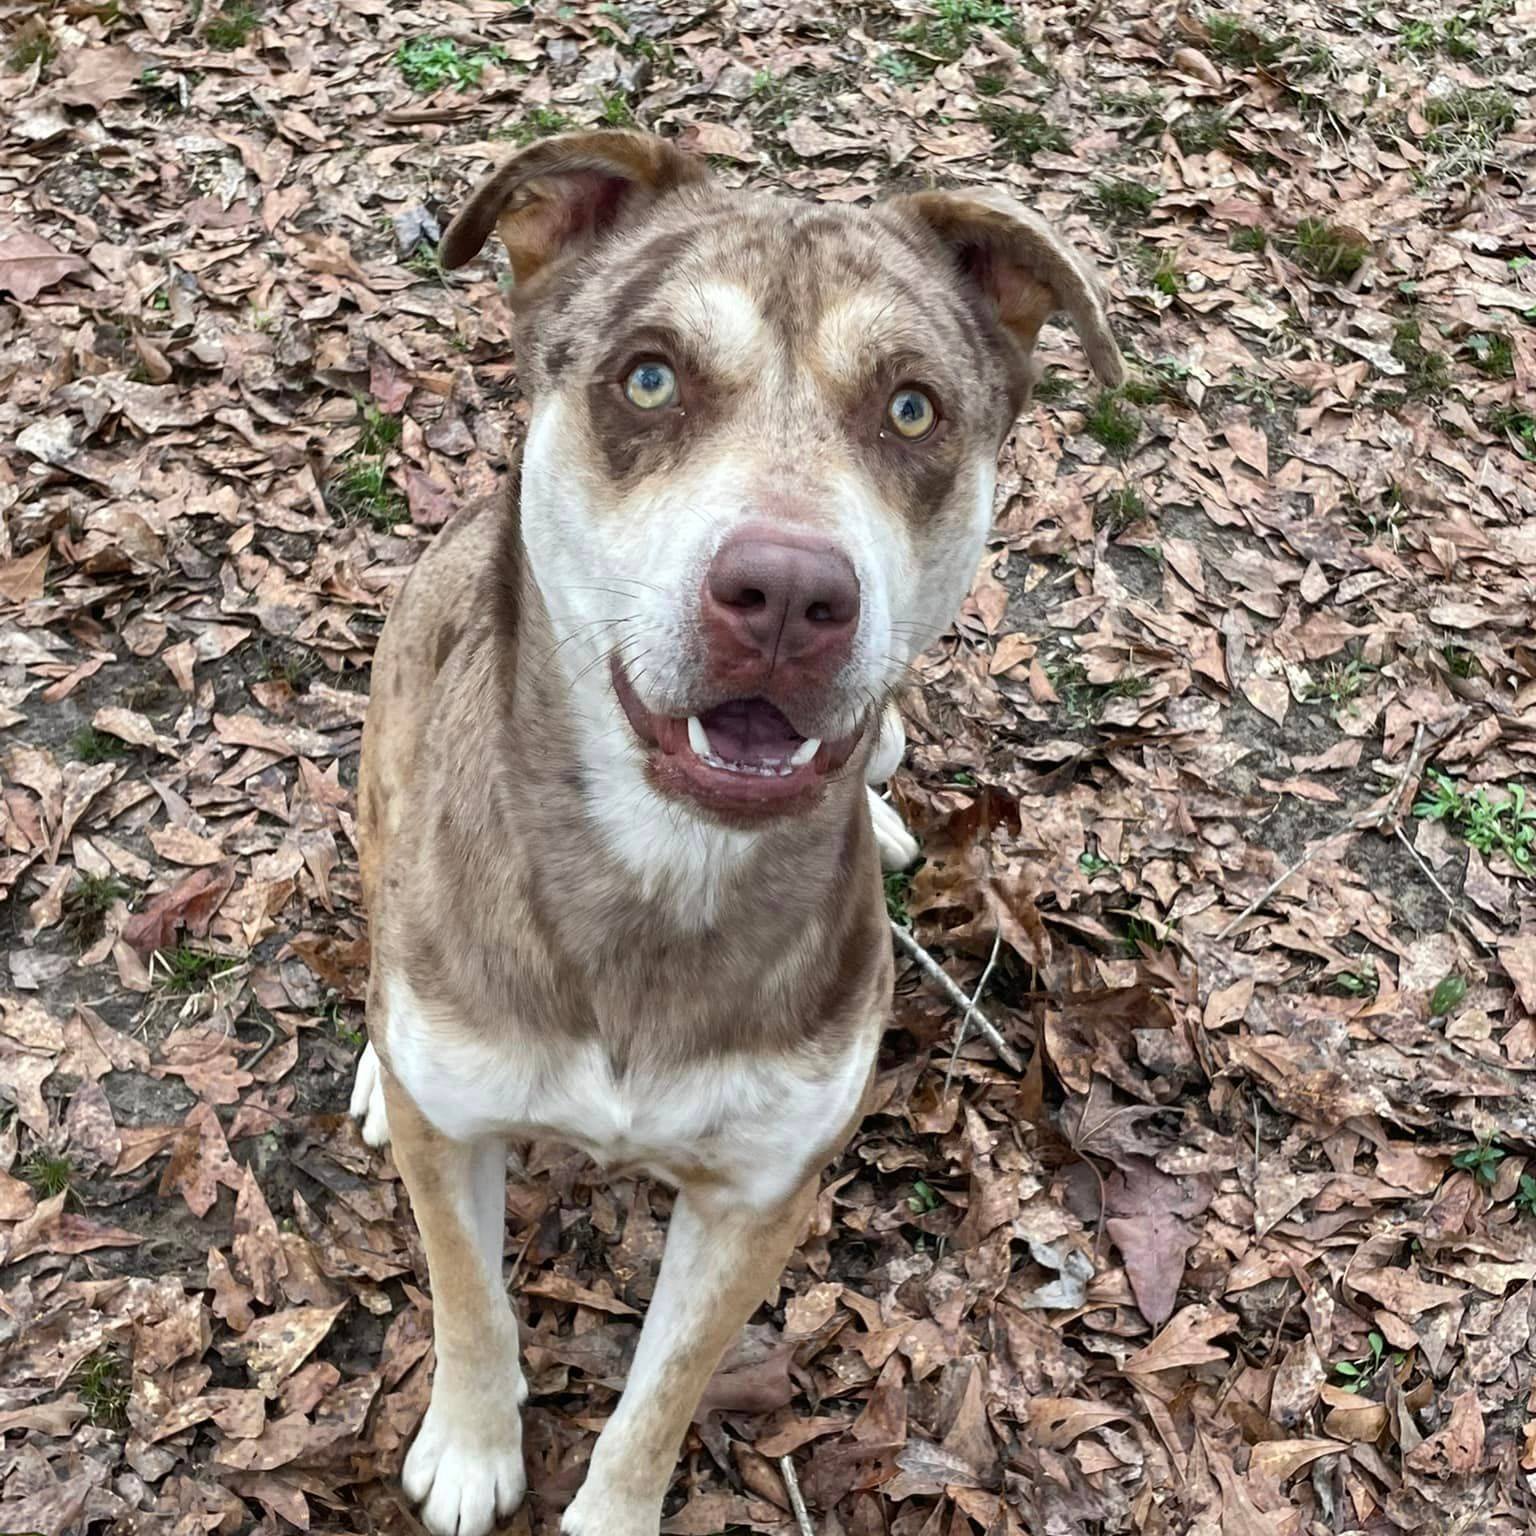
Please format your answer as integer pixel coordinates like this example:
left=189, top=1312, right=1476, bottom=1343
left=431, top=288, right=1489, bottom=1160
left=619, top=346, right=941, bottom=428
left=703, top=527, right=859, bottom=670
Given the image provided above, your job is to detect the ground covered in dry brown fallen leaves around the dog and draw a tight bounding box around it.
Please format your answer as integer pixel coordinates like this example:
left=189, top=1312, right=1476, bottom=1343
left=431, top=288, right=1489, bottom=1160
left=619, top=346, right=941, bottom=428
left=0, top=0, right=1536, bottom=1536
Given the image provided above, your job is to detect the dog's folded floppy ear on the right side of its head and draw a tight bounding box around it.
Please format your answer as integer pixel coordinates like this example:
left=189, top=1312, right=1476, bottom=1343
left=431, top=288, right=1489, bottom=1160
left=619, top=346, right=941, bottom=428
left=888, top=190, right=1126, bottom=387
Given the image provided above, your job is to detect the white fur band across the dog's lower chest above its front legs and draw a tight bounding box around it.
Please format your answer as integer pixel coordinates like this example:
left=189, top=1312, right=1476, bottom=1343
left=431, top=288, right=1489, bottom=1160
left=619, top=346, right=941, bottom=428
left=387, top=978, right=872, bottom=1206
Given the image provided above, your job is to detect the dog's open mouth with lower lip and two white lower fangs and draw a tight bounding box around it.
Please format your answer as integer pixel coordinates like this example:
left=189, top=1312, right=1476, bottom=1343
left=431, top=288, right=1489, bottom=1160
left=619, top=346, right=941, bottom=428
left=613, top=657, right=863, bottom=814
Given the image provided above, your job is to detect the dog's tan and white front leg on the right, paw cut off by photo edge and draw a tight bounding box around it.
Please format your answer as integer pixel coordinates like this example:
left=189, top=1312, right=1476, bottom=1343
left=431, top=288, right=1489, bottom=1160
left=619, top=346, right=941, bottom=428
left=561, top=1177, right=816, bottom=1536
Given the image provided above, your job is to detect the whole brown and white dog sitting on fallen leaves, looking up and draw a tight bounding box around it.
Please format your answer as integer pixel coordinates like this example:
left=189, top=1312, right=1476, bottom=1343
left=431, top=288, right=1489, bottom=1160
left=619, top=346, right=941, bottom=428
left=352, top=132, right=1121, bottom=1536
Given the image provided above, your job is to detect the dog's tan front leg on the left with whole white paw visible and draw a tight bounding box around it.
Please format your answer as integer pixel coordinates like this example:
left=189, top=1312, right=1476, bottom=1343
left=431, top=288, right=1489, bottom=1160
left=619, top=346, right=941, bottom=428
left=384, top=1072, right=527, bottom=1536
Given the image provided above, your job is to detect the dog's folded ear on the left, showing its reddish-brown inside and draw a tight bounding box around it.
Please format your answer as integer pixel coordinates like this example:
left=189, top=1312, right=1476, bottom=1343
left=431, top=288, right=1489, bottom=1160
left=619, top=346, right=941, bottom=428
left=438, top=129, right=710, bottom=284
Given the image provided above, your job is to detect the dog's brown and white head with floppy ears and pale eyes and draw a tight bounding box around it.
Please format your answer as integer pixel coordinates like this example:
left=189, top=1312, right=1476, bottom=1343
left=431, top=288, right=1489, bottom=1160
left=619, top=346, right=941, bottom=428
left=442, top=132, right=1121, bottom=823
